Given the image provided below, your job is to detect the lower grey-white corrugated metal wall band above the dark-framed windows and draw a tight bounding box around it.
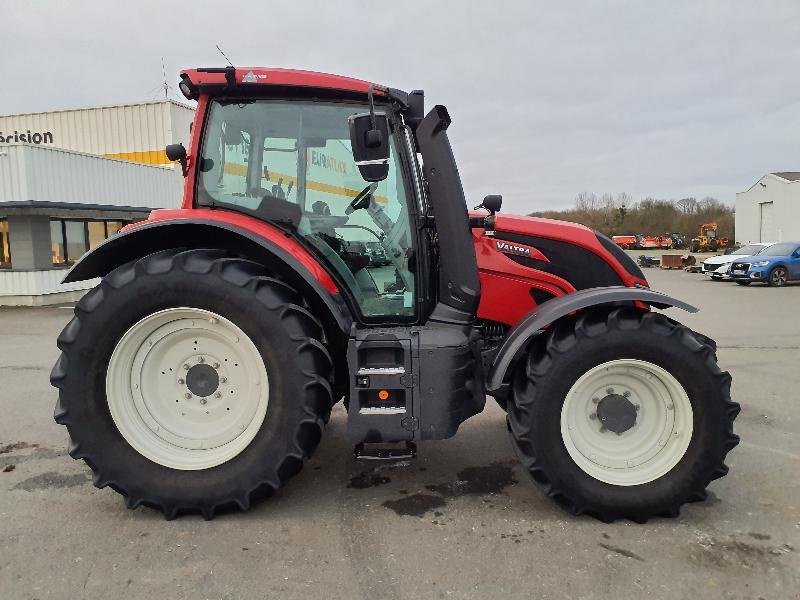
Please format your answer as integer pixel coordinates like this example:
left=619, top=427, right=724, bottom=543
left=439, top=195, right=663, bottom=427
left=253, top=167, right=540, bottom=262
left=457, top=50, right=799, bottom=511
left=0, top=144, right=183, bottom=208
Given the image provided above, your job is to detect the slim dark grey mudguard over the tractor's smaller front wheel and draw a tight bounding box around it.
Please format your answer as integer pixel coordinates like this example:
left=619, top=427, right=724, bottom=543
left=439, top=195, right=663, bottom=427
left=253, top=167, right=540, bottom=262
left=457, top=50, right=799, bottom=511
left=486, top=286, right=698, bottom=394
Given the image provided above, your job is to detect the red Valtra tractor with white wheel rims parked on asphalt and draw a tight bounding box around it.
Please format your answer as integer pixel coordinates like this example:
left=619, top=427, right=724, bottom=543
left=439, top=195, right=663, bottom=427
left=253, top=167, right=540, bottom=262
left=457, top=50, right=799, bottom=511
left=51, top=67, right=739, bottom=522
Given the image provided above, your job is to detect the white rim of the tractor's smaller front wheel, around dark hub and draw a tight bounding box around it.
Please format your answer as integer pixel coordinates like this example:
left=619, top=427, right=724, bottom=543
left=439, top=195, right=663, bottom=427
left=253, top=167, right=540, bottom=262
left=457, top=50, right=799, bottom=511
left=561, top=359, right=693, bottom=486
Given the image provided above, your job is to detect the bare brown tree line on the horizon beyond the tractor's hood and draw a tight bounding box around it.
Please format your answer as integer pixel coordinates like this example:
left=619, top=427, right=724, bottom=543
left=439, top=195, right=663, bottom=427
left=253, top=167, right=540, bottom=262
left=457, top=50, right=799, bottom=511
left=531, top=192, right=734, bottom=240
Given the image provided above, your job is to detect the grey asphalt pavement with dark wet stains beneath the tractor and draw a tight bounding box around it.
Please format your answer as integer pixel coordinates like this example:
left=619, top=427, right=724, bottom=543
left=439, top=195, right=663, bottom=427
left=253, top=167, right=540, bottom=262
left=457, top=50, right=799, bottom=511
left=0, top=269, right=800, bottom=600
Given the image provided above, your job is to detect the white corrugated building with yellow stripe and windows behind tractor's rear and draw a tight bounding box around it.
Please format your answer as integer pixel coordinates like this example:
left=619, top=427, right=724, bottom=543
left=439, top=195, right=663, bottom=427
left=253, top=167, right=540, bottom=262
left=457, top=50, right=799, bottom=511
left=0, top=101, right=194, bottom=305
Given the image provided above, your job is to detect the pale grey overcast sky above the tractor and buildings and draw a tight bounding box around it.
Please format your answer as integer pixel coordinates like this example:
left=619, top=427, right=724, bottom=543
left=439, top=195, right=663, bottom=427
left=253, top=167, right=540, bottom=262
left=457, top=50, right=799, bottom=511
left=0, top=0, right=800, bottom=212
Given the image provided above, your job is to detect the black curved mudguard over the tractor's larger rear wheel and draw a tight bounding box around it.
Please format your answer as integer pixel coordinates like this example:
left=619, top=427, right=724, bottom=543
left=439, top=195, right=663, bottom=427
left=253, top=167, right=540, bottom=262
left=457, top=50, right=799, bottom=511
left=63, top=218, right=352, bottom=338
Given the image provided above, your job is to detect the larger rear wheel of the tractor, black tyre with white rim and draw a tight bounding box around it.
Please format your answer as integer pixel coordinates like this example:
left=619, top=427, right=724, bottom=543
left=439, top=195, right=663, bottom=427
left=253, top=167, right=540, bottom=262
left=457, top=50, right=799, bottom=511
left=51, top=250, right=332, bottom=519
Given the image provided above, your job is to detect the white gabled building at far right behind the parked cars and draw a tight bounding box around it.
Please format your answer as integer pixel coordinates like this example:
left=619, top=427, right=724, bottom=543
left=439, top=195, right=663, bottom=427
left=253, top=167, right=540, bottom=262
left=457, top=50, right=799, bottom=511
left=736, top=171, right=800, bottom=244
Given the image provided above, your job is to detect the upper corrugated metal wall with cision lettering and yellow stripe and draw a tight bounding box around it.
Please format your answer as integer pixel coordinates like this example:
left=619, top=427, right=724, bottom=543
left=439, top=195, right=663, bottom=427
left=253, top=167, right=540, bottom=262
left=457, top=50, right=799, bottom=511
left=0, top=100, right=194, bottom=164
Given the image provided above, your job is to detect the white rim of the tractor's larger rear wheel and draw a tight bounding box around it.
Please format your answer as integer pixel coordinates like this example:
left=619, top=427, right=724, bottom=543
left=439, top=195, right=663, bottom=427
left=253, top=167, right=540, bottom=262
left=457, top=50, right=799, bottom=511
left=106, top=308, right=269, bottom=470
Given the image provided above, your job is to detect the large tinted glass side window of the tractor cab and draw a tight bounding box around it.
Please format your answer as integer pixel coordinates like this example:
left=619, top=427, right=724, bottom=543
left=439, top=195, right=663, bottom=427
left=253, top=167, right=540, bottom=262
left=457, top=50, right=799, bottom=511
left=197, top=100, right=416, bottom=320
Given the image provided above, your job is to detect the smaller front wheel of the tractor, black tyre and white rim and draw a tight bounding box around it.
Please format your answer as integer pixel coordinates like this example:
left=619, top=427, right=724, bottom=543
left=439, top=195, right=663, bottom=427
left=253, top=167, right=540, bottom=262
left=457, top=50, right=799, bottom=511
left=508, top=308, right=739, bottom=522
